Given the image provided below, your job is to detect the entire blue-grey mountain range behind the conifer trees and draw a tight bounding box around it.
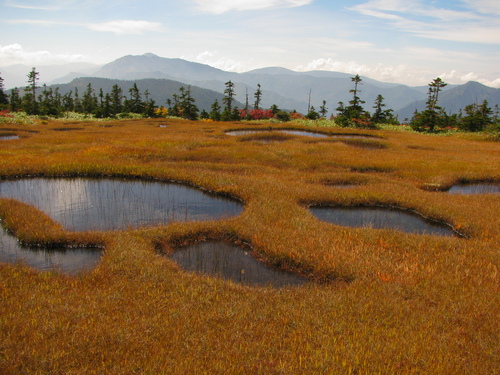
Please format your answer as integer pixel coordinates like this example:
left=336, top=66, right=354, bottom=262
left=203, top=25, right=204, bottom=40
left=1, top=53, right=500, bottom=121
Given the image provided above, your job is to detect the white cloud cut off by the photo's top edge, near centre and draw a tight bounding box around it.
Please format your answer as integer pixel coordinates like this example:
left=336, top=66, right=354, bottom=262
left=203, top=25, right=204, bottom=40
left=192, top=0, right=313, bottom=14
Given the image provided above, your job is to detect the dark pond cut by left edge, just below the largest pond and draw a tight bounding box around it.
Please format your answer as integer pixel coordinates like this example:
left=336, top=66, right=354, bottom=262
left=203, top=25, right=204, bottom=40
left=0, top=227, right=102, bottom=274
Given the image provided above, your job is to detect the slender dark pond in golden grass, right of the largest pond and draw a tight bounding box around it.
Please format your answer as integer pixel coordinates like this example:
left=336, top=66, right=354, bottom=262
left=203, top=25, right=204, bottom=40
left=310, top=207, right=456, bottom=236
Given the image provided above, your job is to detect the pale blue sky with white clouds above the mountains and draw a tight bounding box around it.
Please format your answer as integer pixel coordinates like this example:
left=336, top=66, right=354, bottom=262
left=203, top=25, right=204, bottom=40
left=0, top=0, right=500, bottom=88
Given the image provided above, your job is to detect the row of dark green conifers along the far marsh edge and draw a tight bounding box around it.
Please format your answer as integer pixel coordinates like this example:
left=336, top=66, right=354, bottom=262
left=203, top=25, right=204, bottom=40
left=0, top=68, right=500, bottom=132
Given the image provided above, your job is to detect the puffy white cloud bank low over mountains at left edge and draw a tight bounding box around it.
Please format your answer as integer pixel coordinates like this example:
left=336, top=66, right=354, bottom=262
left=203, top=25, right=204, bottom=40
left=0, top=43, right=88, bottom=66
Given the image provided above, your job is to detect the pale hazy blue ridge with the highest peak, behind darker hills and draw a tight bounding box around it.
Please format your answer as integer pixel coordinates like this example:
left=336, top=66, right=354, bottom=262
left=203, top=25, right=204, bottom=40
left=90, top=54, right=425, bottom=113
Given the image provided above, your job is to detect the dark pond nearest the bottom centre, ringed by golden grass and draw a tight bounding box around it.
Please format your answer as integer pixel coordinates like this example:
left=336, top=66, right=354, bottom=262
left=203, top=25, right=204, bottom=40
left=170, top=242, right=306, bottom=287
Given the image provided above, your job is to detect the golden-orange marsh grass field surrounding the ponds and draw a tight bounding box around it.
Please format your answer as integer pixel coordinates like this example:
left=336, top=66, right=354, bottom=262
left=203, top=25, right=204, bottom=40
left=0, top=119, right=500, bottom=374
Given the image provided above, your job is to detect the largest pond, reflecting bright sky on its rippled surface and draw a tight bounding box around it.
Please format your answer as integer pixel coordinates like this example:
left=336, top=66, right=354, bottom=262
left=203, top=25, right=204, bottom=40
left=0, top=178, right=243, bottom=231
